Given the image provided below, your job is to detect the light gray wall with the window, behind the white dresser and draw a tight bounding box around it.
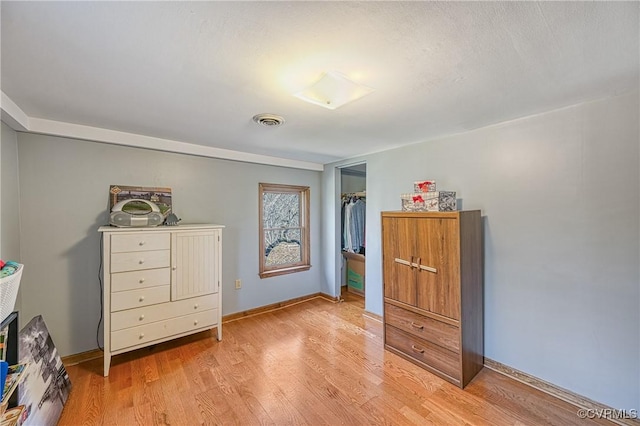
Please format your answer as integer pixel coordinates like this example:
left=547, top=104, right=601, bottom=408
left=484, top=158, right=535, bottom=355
left=18, top=133, right=323, bottom=356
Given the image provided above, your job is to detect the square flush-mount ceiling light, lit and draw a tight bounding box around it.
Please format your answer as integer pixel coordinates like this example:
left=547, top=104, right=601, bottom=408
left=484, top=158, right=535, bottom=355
left=294, top=71, right=374, bottom=109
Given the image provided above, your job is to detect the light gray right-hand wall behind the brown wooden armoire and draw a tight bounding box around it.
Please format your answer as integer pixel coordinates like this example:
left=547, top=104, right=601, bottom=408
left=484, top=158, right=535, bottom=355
left=323, top=92, right=640, bottom=409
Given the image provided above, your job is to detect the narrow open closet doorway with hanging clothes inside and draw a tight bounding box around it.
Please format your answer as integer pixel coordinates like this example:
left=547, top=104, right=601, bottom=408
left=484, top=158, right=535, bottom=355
left=340, top=163, right=367, bottom=298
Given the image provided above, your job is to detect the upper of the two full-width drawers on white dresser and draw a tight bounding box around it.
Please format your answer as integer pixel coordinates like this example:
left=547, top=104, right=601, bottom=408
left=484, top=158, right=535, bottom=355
left=111, top=295, right=218, bottom=331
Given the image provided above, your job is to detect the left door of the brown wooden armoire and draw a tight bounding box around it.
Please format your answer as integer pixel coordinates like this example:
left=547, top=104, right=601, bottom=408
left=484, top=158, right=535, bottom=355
left=382, top=217, right=417, bottom=306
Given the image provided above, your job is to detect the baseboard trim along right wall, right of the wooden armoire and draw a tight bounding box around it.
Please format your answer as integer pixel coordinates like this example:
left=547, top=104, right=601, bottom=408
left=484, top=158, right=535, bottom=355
left=484, top=357, right=640, bottom=426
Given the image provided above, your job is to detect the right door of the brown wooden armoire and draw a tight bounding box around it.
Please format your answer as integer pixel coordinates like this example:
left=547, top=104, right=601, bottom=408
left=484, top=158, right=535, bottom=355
left=413, top=218, right=460, bottom=320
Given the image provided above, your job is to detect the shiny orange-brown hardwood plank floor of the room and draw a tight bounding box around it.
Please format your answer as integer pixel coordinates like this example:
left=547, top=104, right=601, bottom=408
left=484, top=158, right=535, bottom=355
left=59, top=294, right=611, bottom=426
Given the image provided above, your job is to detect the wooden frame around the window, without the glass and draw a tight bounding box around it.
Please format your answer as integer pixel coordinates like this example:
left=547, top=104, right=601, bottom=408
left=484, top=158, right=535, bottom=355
left=258, top=182, right=311, bottom=278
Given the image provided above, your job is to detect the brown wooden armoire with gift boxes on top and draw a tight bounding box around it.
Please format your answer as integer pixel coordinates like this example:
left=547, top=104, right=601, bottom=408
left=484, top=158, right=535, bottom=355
left=382, top=210, right=484, bottom=388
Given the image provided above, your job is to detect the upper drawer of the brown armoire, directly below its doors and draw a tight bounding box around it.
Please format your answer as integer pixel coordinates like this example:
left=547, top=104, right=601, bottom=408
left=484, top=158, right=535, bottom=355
left=384, top=303, right=460, bottom=352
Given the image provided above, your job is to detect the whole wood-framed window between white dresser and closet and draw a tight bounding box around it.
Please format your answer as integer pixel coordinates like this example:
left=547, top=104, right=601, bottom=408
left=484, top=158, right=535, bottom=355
left=259, top=183, right=311, bottom=278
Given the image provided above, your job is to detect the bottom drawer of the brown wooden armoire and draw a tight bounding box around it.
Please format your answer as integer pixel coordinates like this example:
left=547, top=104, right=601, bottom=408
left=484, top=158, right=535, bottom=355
left=385, top=325, right=460, bottom=380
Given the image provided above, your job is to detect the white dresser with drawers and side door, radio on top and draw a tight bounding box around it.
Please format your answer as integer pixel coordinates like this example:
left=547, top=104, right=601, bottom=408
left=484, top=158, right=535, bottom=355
left=99, top=225, right=223, bottom=376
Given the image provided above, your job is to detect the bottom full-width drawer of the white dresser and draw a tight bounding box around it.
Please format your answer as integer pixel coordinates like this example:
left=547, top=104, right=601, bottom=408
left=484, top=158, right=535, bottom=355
left=111, top=309, right=218, bottom=351
